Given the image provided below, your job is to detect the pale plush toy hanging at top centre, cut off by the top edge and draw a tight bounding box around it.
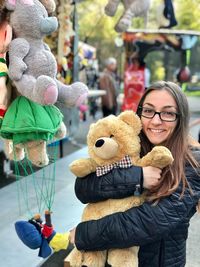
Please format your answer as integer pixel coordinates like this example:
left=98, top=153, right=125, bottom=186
left=105, top=0, right=151, bottom=32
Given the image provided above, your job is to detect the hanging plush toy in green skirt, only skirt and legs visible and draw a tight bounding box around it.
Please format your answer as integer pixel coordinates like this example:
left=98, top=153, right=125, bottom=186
left=0, top=96, right=66, bottom=167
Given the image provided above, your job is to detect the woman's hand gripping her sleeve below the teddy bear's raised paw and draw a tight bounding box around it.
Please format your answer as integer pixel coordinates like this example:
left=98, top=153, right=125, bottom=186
left=142, top=166, right=162, bottom=189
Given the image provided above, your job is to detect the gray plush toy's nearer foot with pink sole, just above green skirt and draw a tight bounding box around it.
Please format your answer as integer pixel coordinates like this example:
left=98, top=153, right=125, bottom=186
left=34, top=75, right=58, bottom=105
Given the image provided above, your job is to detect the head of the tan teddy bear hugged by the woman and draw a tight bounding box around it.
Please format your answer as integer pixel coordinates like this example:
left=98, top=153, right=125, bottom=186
left=87, top=111, right=142, bottom=166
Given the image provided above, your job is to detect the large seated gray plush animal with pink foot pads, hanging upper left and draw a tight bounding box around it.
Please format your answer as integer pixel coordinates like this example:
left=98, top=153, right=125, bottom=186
left=6, top=0, right=88, bottom=108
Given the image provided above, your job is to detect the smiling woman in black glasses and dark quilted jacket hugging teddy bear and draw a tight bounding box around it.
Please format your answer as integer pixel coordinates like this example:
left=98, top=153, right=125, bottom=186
left=70, top=81, right=200, bottom=267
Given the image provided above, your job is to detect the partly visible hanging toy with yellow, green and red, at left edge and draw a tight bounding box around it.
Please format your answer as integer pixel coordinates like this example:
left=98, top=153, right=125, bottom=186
left=0, top=2, right=12, bottom=125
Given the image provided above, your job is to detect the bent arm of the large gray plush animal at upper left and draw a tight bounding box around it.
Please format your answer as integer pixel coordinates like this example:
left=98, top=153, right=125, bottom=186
left=9, top=38, right=30, bottom=81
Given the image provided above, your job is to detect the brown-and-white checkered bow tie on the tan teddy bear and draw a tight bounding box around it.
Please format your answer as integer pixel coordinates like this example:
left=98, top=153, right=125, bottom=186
left=96, top=155, right=133, bottom=176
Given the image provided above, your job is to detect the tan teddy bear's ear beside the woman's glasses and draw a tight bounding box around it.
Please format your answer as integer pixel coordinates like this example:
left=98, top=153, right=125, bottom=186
left=118, top=110, right=142, bottom=134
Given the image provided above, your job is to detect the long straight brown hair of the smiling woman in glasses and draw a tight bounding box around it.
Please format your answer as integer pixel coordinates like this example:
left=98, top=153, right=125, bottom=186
left=137, top=81, right=199, bottom=200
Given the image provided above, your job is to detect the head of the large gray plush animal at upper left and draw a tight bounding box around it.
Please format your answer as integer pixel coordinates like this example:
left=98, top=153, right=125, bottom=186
left=6, top=0, right=58, bottom=38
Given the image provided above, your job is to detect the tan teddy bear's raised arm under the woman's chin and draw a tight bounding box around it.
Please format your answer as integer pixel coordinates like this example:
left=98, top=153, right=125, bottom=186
left=136, top=146, right=174, bottom=169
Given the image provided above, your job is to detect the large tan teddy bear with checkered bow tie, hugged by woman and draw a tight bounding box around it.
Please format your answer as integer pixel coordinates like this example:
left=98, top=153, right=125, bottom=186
left=66, top=111, right=173, bottom=267
